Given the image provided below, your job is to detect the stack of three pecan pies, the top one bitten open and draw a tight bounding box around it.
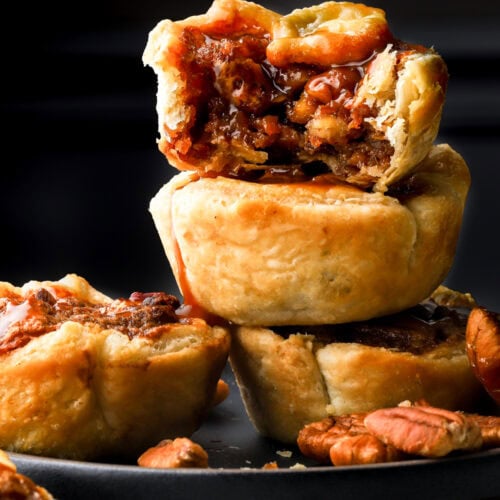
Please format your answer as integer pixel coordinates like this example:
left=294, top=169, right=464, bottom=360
left=143, top=0, right=480, bottom=442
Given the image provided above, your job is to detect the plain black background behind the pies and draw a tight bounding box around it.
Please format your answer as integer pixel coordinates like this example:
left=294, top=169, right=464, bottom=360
left=0, top=0, right=500, bottom=310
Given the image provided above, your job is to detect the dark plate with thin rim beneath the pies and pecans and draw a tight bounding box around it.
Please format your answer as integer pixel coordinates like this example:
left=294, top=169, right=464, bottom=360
left=11, top=369, right=500, bottom=500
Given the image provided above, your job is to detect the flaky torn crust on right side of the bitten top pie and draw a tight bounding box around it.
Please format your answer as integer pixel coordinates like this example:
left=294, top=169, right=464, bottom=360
left=356, top=47, right=447, bottom=192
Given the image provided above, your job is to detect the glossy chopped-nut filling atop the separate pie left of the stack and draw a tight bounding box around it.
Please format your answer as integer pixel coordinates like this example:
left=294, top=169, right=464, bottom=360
left=0, top=288, right=179, bottom=354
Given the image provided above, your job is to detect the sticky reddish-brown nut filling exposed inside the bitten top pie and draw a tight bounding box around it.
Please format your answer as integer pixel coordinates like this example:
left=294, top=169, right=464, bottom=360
left=160, top=26, right=425, bottom=188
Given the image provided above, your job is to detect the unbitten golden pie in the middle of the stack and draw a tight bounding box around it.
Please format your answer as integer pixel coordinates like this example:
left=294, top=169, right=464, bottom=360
left=150, top=145, right=470, bottom=326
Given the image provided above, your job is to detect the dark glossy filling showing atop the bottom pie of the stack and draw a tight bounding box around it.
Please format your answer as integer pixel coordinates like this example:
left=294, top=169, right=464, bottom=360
left=272, top=301, right=469, bottom=355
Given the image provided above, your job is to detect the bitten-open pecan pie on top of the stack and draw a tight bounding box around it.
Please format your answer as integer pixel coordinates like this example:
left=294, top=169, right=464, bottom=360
left=143, top=0, right=448, bottom=191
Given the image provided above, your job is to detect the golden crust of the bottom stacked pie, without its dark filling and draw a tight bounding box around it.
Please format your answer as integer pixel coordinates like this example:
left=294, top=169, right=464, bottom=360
left=230, top=314, right=482, bottom=443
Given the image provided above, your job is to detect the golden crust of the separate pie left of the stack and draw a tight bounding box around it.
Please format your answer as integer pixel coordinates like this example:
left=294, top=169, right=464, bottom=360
left=0, top=275, right=230, bottom=460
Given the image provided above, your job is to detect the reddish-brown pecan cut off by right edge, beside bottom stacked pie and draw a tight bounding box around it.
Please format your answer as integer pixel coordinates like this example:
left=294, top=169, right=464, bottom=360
left=465, top=307, right=500, bottom=405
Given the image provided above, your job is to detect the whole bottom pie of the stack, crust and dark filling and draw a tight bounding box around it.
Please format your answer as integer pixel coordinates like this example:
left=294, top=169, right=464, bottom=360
left=230, top=294, right=483, bottom=443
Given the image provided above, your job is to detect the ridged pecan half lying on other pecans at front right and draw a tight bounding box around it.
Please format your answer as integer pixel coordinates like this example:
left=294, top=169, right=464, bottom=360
left=364, top=406, right=482, bottom=457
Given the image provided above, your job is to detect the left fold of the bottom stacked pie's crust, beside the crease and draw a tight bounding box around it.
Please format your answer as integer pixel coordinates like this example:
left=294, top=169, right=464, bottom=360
left=230, top=327, right=329, bottom=443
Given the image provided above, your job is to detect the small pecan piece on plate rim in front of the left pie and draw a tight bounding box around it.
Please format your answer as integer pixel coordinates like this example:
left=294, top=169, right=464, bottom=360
left=137, top=438, right=208, bottom=469
